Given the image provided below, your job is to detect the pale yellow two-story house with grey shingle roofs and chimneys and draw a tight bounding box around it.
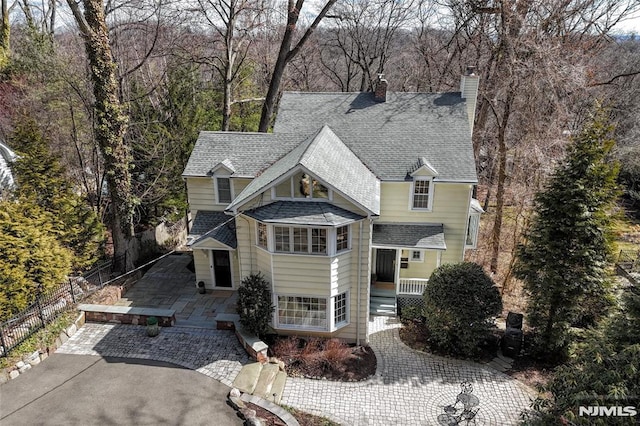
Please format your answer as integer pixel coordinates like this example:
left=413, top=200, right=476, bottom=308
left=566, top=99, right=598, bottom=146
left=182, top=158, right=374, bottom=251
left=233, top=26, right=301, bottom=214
left=183, top=70, right=482, bottom=341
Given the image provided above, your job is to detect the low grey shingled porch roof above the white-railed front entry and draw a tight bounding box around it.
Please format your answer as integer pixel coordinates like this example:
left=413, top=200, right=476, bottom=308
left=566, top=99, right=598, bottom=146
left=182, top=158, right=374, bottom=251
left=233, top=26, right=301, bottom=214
left=372, top=223, right=447, bottom=250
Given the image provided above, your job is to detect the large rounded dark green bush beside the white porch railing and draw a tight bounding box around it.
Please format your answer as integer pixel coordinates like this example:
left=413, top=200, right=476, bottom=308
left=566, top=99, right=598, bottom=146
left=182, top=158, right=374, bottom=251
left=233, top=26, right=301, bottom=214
left=423, top=262, right=502, bottom=357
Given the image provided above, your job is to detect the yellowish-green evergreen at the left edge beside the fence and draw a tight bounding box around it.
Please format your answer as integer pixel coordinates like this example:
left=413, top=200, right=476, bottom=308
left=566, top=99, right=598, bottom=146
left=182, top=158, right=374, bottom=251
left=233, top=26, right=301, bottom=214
left=0, top=200, right=72, bottom=321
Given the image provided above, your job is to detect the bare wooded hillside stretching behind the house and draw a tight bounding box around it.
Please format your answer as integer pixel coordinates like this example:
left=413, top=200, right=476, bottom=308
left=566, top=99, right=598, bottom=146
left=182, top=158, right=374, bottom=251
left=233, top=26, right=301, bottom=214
left=0, top=0, right=640, bottom=276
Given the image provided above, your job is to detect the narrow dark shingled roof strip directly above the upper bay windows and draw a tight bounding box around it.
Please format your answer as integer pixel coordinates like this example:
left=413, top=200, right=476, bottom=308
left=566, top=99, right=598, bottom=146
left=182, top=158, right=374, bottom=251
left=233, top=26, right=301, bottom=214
left=243, top=201, right=363, bottom=226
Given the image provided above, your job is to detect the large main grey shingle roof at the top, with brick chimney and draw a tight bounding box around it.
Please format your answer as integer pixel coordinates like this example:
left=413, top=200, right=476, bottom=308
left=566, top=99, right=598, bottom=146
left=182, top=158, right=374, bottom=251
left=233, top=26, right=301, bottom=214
left=273, top=92, right=477, bottom=182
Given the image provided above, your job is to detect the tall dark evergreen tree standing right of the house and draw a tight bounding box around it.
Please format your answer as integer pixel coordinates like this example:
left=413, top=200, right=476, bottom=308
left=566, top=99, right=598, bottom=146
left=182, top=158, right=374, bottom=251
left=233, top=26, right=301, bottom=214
left=515, top=107, right=618, bottom=360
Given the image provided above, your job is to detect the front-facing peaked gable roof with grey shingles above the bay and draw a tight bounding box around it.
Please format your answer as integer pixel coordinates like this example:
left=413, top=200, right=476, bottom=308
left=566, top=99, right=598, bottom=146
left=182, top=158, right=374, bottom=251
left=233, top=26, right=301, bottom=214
left=228, top=126, right=380, bottom=214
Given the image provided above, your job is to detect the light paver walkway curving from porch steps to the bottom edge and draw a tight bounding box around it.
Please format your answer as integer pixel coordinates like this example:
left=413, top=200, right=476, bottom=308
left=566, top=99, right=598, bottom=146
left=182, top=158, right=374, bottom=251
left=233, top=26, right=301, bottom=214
left=282, top=316, right=535, bottom=426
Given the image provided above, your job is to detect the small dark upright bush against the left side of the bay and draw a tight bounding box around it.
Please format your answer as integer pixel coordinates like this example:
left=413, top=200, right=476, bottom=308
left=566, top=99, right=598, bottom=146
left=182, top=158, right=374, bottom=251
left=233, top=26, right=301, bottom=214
left=236, top=272, right=274, bottom=336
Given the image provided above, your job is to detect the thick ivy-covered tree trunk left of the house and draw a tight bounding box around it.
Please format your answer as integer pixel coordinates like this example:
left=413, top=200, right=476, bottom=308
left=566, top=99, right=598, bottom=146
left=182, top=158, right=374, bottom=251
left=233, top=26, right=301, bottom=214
left=67, top=0, right=135, bottom=271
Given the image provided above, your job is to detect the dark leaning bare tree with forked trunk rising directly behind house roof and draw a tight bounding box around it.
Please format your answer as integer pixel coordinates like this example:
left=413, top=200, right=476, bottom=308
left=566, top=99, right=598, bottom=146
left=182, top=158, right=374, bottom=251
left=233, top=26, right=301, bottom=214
left=258, top=0, right=336, bottom=132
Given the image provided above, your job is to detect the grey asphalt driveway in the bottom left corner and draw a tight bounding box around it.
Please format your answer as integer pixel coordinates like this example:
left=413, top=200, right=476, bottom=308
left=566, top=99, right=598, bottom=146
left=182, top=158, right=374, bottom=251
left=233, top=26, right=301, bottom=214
left=0, top=353, right=242, bottom=426
